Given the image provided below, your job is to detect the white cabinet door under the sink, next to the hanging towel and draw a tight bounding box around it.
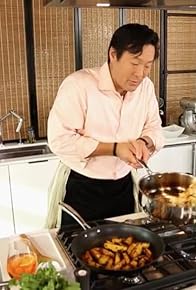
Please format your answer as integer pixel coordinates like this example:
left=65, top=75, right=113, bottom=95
left=10, top=159, right=59, bottom=233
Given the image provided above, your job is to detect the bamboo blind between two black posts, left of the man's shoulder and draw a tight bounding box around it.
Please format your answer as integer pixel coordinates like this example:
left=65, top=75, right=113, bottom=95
left=33, top=0, right=75, bottom=137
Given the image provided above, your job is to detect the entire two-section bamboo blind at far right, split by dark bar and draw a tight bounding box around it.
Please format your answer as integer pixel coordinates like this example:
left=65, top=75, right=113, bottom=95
left=166, top=11, right=196, bottom=124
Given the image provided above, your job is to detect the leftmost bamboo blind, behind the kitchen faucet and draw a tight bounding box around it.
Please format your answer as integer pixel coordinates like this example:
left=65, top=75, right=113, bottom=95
left=0, top=0, right=29, bottom=140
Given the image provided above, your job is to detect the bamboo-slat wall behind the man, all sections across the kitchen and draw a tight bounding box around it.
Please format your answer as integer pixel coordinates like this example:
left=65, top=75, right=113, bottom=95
left=0, top=0, right=196, bottom=140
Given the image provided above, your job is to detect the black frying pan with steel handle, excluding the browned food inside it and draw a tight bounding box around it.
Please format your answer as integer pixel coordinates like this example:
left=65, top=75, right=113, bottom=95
left=59, top=202, right=164, bottom=275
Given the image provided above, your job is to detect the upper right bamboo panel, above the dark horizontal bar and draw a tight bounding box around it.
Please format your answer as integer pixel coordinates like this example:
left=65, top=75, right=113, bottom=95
left=168, top=14, right=196, bottom=70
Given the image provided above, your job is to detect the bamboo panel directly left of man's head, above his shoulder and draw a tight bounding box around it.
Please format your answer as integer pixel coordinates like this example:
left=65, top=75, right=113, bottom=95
left=81, top=8, right=119, bottom=67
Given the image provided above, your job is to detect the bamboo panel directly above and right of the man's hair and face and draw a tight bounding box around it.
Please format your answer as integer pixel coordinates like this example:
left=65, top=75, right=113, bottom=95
left=124, top=9, right=160, bottom=97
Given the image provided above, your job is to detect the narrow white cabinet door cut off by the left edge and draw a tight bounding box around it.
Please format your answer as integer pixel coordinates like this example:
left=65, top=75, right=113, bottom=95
left=0, top=166, right=14, bottom=237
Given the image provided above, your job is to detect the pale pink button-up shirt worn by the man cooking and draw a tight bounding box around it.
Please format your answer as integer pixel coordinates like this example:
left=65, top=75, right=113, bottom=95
left=48, top=63, right=163, bottom=179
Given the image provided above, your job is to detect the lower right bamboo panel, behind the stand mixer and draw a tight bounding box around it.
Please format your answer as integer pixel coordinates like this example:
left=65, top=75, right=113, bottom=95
left=167, top=74, right=196, bottom=124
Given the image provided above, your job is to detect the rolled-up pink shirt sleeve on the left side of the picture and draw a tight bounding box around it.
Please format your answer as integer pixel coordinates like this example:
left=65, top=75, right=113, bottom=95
left=48, top=77, right=98, bottom=168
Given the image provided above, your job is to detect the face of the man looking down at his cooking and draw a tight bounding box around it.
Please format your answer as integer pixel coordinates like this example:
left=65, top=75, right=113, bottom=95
left=109, top=44, right=155, bottom=94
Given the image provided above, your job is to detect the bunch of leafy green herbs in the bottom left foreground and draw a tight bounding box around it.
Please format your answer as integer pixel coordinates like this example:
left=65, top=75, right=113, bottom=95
left=9, top=264, right=80, bottom=290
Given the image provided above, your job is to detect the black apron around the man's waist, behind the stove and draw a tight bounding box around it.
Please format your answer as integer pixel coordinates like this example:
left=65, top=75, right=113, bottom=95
left=61, top=170, right=134, bottom=226
